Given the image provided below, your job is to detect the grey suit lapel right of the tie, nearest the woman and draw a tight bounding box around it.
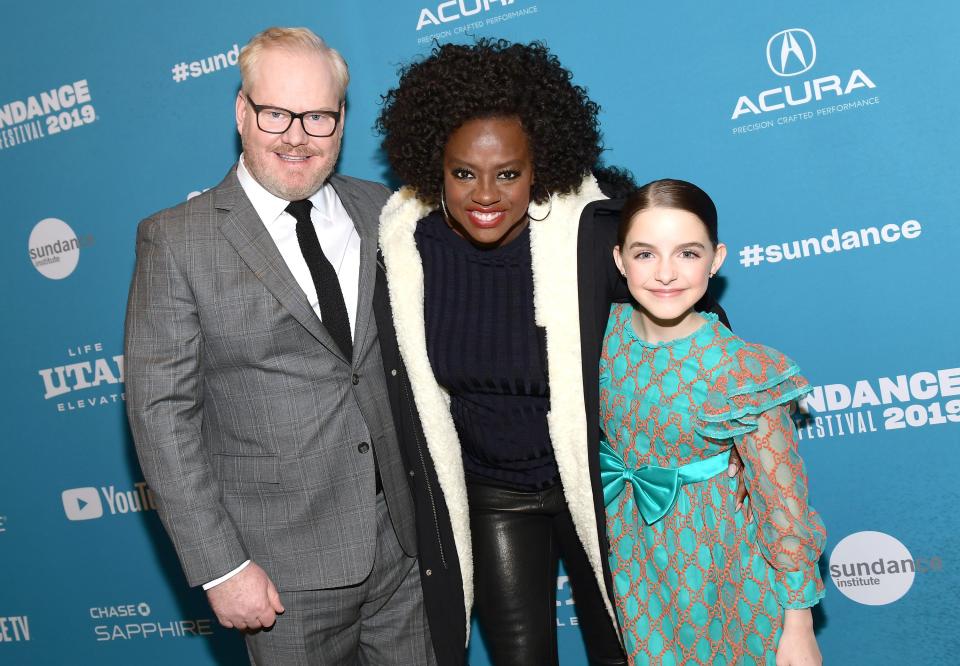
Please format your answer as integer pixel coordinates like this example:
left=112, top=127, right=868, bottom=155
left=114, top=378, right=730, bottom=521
left=330, top=174, right=380, bottom=358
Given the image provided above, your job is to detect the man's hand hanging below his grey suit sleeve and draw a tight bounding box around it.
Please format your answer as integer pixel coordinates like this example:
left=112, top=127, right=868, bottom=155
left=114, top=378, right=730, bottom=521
left=207, top=562, right=284, bottom=631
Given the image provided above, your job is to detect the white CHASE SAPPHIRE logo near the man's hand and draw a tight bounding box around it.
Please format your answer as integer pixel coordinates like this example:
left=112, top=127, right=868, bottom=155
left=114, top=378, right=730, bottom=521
left=88, top=601, right=213, bottom=642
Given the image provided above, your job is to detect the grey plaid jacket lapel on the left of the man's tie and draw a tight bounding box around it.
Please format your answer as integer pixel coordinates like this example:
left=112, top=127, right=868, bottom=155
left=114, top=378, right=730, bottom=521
left=214, top=169, right=350, bottom=363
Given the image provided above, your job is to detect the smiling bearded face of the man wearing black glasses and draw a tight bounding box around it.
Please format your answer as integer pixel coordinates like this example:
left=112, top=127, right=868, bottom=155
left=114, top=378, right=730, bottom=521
left=236, top=48, right=343, bottom=201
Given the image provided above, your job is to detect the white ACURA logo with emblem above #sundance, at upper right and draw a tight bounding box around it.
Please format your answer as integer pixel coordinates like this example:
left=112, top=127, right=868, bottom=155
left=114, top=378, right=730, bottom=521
left=730, top=28, right=880, bottom=134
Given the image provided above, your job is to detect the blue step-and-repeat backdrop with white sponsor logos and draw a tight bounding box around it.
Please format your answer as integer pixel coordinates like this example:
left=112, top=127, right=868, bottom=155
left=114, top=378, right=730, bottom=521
left=0, top=0, right=960, bottom=665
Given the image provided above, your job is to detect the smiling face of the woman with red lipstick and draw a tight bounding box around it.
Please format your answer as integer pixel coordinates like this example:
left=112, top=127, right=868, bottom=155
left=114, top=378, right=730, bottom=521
left=443, top=118, right=533, bottom=248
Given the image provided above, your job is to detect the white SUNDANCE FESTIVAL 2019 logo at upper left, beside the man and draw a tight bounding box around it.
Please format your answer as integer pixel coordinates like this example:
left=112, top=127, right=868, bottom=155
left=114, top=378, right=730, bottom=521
left=0, top=79, right=97, bottom=150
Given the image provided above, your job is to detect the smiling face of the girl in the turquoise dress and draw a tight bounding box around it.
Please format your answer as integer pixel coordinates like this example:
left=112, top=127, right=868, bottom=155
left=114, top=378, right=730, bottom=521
left=613, top=207, right=726, bottom=341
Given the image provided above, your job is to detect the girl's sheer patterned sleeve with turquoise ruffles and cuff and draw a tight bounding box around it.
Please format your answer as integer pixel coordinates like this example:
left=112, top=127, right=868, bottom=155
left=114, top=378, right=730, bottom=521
left=695, top=344, right=826, bottom=608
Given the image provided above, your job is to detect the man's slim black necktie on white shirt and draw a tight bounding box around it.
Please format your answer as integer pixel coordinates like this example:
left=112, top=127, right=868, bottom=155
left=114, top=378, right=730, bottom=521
left=286, top=199, right=353, bottom=360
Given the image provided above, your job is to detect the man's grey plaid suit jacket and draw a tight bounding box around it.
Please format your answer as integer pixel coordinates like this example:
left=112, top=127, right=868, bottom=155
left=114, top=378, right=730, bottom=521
left=125, top=168, right=416, bottom=591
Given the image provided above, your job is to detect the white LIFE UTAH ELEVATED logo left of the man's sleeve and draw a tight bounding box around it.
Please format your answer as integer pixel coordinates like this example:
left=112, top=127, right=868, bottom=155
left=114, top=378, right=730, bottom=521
left=37, top=342, right=126, bottom=413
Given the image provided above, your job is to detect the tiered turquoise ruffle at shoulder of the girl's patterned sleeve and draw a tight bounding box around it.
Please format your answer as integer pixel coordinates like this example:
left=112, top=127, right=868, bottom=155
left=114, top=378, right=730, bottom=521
left=693, top=343, right=812, bottom=439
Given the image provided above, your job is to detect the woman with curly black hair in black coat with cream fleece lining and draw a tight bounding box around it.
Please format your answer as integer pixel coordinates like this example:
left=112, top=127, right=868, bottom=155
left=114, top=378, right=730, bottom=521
left=377, top=40, right=732, bottom=665
